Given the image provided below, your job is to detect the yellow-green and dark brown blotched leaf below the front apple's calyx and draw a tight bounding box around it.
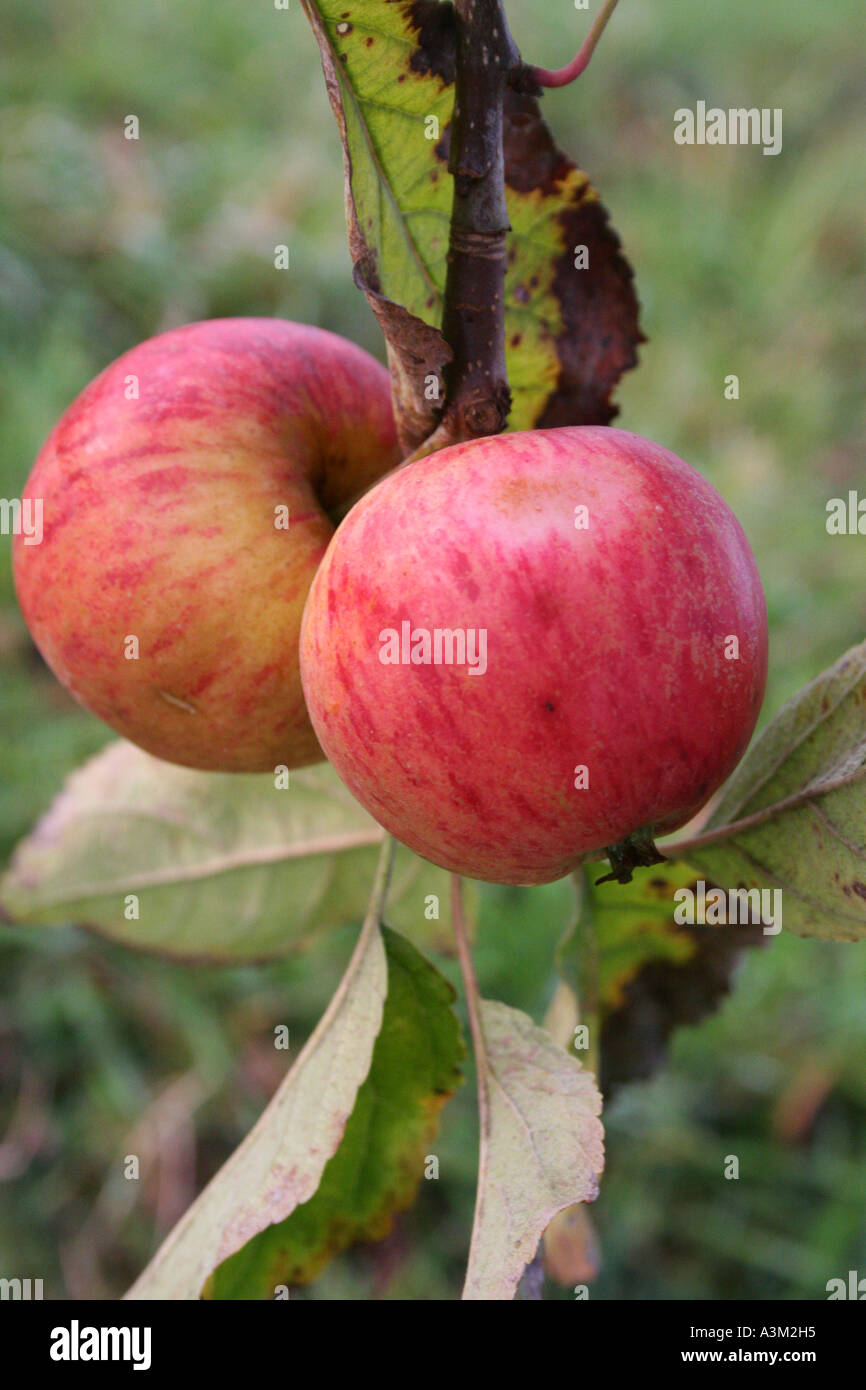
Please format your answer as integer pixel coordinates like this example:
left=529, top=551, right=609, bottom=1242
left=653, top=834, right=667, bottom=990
left=557, top=862, right=767, bottom=1098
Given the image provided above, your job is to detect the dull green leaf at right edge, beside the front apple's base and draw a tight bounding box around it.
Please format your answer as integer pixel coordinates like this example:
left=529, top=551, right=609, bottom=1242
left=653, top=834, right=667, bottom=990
left=681, top=642, right=866, bottom=941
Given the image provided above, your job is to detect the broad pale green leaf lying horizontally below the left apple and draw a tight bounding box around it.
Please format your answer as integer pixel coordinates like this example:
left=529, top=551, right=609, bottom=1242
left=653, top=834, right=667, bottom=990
left=0, top=742, right=475, bottom=962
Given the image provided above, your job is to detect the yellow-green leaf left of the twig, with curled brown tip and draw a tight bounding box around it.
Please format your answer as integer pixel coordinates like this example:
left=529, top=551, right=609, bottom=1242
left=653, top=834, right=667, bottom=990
left=302, top=0, right=453, bottom=453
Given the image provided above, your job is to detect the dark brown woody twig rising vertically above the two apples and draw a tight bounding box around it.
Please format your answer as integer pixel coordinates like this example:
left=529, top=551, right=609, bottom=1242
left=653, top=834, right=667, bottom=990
left=436, top=0, right=520, bottom=452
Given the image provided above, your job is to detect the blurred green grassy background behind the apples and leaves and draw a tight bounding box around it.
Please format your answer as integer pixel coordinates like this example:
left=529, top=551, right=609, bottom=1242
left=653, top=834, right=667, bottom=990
left=0, top=0, right=866, bottom=1300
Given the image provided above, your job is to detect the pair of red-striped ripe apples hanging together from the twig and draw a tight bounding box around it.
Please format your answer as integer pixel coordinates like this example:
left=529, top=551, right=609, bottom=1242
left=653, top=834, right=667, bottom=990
left=14, top=318, right=767, bottom=884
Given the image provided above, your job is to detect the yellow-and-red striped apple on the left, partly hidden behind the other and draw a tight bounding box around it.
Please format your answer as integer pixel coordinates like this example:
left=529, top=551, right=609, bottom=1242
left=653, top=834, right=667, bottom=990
left=14, top=318, right=399, bottom=771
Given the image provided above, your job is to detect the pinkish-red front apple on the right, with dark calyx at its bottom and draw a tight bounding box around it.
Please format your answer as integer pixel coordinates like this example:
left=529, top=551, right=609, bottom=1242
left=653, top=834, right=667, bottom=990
left=300, top=427, right=767, bottom=884
